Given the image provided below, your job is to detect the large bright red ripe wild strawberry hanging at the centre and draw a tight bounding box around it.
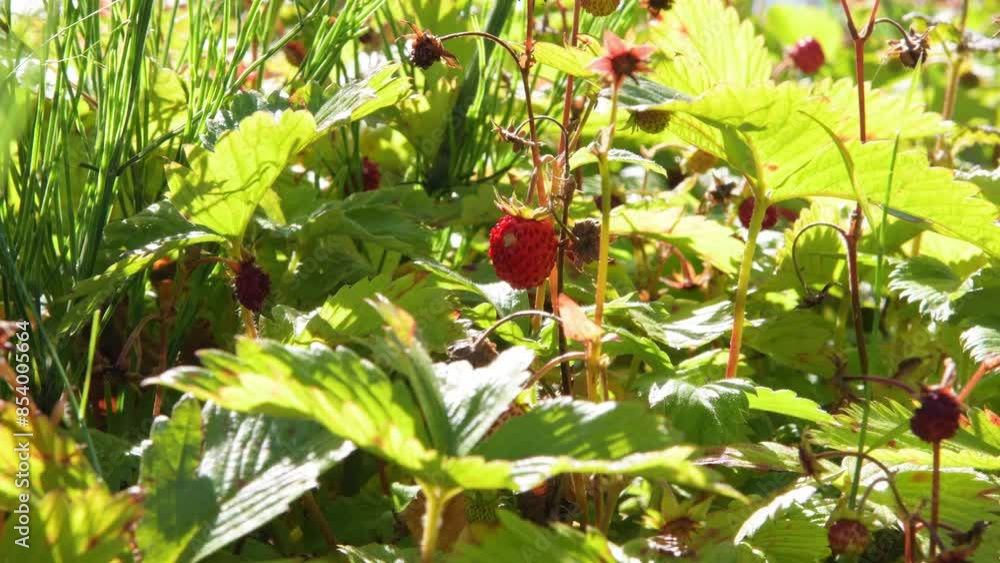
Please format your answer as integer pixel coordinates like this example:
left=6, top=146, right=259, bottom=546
left=489, top=215, right=559, bottom=289
